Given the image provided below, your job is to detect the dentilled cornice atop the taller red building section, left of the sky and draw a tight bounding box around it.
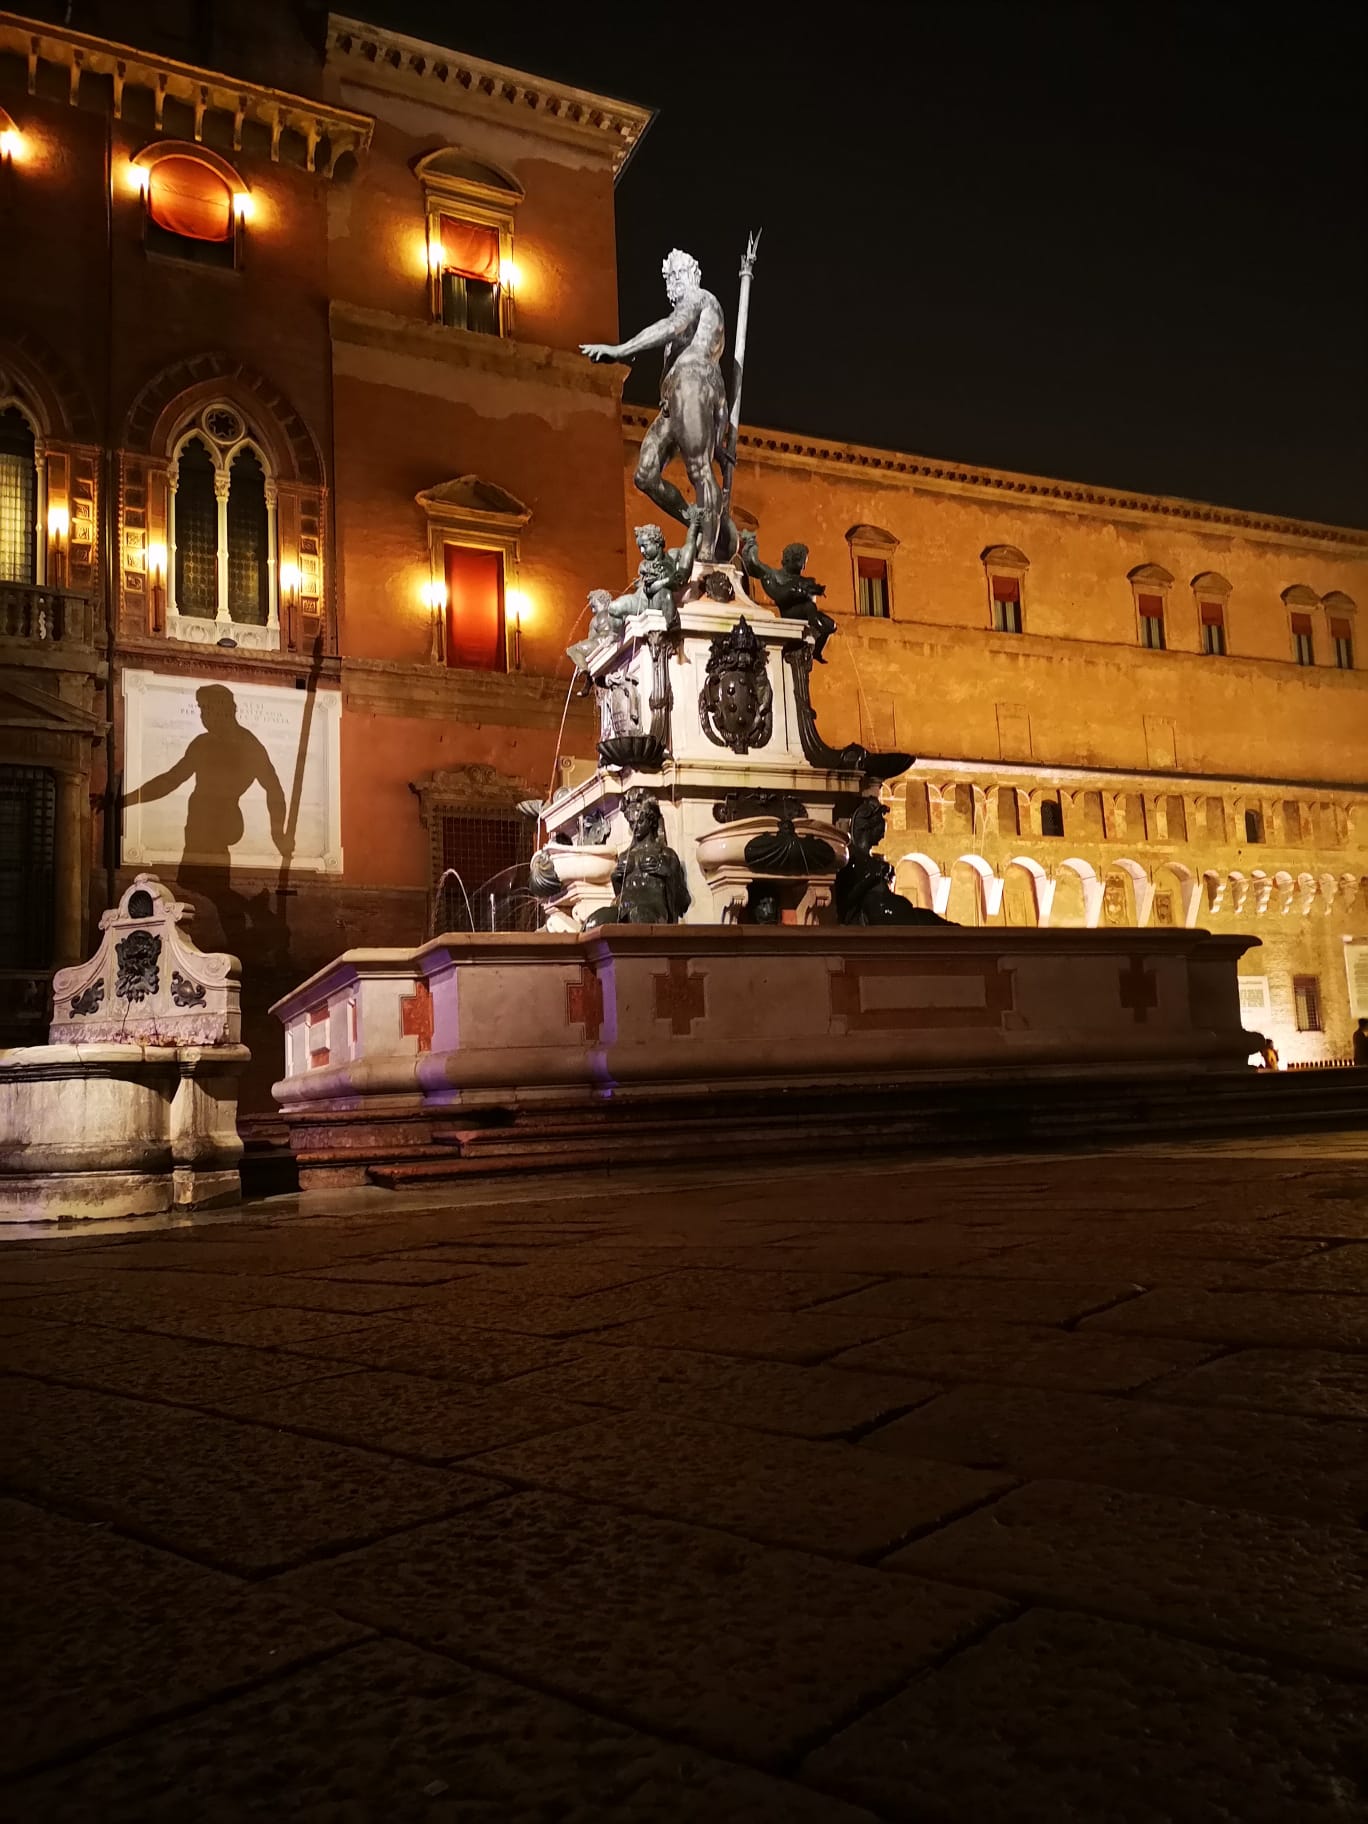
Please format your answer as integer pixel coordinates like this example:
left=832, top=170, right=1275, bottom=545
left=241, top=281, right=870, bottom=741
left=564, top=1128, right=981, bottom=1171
left=328, top=13, right=653, bottom=175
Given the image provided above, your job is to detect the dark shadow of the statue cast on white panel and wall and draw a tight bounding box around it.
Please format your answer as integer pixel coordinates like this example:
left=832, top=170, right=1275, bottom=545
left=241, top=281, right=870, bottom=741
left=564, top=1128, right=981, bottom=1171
left=124, top=684, right=294, bottom=961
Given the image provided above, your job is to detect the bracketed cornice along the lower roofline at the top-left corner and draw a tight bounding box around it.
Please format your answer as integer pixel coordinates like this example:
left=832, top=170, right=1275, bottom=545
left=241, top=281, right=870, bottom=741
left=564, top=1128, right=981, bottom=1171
left=0, top=13, right=374, bottom=177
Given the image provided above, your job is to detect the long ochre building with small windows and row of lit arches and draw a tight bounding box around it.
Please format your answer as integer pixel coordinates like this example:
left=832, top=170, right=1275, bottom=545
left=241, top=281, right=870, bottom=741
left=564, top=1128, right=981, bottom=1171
left=674, top=409, right=1368, bottom=1063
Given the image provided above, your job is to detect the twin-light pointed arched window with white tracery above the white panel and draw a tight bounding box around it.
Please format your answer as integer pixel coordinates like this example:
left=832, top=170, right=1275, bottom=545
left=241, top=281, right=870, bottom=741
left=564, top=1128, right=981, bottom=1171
left=166, top=401, right=279, bottom=651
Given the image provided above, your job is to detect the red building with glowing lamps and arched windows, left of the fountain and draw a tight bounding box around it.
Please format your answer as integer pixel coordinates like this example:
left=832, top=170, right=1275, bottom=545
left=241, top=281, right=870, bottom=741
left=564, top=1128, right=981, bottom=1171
left=0, top=0, right=649, bottom=1100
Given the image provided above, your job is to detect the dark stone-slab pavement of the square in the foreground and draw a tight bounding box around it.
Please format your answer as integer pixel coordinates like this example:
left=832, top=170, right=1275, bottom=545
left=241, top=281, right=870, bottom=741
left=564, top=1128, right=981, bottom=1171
left=0, top=1136, right=1368, bottom=1824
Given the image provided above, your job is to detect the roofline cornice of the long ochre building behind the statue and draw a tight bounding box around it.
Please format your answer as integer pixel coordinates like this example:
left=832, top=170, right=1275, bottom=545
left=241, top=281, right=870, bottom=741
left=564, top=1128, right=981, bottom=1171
left=622, top=405, right=1368, bottom=556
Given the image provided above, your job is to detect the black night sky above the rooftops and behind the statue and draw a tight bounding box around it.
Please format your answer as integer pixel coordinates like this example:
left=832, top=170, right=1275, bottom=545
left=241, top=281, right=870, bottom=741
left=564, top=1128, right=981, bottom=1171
left=356, top=0, right=1368, bottom=525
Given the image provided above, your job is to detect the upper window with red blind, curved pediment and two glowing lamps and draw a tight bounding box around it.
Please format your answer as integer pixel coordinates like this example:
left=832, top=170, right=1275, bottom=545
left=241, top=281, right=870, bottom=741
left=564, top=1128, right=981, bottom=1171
left=414, top=146, right=523, bottom=336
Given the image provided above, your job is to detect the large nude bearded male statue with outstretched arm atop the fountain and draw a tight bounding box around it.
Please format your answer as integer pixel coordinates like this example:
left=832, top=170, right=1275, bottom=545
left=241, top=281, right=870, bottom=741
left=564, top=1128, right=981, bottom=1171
left=580, top=248, right=730, bottom=558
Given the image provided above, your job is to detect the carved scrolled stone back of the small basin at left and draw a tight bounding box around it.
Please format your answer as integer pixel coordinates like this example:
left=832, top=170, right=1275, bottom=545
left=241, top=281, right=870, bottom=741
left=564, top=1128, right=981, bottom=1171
left=47, top=874, right=243, bottom=1045
